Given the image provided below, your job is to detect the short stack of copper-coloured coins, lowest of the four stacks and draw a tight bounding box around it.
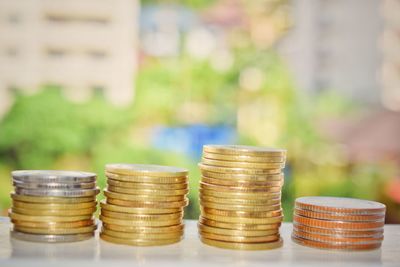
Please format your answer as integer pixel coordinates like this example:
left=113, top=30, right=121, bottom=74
left=292, top=197, right=386, bottom=250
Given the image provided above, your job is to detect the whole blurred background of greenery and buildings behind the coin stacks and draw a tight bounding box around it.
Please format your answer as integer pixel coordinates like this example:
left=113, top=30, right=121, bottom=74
left=0, top=0, right=400, bottom=223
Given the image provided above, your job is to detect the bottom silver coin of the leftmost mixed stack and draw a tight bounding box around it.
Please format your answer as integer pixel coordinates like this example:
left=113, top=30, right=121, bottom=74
left=10, top=231, right=94, bottom=243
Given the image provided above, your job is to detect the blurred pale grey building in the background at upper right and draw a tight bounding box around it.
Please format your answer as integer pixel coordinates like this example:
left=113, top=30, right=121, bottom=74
left=280, top=0, right=382, bottom=104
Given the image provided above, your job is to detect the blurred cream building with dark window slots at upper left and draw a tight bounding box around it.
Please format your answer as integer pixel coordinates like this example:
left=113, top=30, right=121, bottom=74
left=0, top=0, right=139, bottom=115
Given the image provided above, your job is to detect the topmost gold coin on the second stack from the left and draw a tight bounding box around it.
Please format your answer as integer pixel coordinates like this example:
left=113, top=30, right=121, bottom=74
left=106, top=163, right=189, bottom=177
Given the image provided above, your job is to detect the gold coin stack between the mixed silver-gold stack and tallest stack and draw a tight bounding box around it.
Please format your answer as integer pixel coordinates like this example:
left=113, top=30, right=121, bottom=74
left=100, top=164, right=189, bottom=246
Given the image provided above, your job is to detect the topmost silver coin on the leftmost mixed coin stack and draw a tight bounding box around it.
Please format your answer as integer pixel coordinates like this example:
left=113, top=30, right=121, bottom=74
left=11, top=170, right=96, bottom=183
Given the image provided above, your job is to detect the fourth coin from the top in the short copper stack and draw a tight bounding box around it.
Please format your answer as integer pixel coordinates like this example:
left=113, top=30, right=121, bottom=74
left=293, top=222, right=383, bottom=237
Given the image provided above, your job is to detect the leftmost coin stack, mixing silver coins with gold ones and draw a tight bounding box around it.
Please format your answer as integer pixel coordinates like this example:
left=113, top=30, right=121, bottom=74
left=9, top=170, right=99, bottom=243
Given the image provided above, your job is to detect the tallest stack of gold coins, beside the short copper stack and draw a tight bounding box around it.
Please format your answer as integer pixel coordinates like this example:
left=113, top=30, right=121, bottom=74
left=198, top=145, right=286, bottom=250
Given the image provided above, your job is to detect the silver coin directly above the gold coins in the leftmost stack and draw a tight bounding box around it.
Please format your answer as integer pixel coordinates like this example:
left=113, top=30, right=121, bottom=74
left=15, top=188, right=100, bottom=197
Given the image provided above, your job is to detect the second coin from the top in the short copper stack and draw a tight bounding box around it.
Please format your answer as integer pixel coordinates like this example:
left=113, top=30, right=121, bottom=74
left=294, top=208, right=385, bottom=222
